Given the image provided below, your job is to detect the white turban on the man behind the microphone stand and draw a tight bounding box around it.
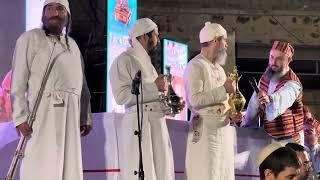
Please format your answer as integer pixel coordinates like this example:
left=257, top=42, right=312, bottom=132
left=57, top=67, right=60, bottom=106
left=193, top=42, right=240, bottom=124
left=129, top=18, right=158, bottom=39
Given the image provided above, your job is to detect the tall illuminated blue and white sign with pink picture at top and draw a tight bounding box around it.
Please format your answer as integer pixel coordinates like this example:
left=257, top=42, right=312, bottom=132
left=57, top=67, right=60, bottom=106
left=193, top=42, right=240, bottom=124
left=106, top=0, right=137, bottom=113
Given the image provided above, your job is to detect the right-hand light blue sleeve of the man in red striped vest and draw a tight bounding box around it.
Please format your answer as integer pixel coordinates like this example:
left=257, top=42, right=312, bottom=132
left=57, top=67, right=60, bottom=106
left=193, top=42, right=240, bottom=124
left=266, top=81, right=302, bottom=121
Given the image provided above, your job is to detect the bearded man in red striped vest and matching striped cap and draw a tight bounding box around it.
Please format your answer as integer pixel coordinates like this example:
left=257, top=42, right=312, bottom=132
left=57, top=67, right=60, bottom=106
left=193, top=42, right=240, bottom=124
left=242, top=41, right=304, bottom=144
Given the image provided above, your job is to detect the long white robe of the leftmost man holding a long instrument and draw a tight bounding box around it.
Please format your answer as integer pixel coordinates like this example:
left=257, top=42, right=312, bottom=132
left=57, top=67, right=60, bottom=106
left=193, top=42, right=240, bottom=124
left=11, top=29, right=91, bottom=180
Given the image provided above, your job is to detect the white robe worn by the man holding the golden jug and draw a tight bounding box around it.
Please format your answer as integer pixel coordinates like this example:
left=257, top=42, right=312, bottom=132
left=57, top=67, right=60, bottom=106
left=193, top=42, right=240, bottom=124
left=184, top=54, right=234, bottom=180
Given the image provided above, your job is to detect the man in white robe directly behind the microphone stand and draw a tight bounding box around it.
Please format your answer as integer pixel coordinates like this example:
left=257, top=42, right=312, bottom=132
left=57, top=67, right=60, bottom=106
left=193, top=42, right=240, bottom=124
left=109, top=18, right=175, bottom=180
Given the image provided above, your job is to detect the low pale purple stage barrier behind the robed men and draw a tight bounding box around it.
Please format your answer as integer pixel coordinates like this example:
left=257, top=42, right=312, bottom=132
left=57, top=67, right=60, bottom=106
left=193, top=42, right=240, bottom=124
left=0, top=113, right=271, bottom=180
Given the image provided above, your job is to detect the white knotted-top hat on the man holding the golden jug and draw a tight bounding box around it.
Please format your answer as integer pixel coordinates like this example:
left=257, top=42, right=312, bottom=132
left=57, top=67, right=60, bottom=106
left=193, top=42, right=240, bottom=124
left=199, top=22, right=227, bottom=43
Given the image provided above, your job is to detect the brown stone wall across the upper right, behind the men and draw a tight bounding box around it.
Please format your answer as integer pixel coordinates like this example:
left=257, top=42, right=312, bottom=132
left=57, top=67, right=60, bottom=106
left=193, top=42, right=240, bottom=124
left=138, top=0, right=320, bottom=117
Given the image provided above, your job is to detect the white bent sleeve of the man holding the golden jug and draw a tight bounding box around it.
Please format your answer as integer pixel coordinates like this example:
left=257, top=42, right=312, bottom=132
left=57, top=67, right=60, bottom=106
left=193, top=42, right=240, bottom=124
left=184, top=62, right=227, bottom=110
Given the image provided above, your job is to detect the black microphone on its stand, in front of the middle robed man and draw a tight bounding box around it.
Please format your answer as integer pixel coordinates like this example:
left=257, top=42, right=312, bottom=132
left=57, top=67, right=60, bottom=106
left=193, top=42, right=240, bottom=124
left=131, top=74, right=144, bottom=180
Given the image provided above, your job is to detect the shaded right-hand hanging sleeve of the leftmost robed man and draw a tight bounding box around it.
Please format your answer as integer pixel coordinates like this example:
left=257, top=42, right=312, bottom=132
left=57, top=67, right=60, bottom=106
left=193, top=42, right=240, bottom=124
left=80, top=57, right=92, bottom=125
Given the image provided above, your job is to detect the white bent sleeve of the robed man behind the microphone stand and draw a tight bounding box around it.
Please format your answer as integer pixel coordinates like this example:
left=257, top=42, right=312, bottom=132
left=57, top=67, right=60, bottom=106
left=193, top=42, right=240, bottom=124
left=109, top=54, right=159, bottom=106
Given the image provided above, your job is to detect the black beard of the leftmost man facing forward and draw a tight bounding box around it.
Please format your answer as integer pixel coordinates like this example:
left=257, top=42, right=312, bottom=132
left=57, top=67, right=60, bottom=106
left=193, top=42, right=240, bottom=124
left=42, top=17, right=64, bottom=35
